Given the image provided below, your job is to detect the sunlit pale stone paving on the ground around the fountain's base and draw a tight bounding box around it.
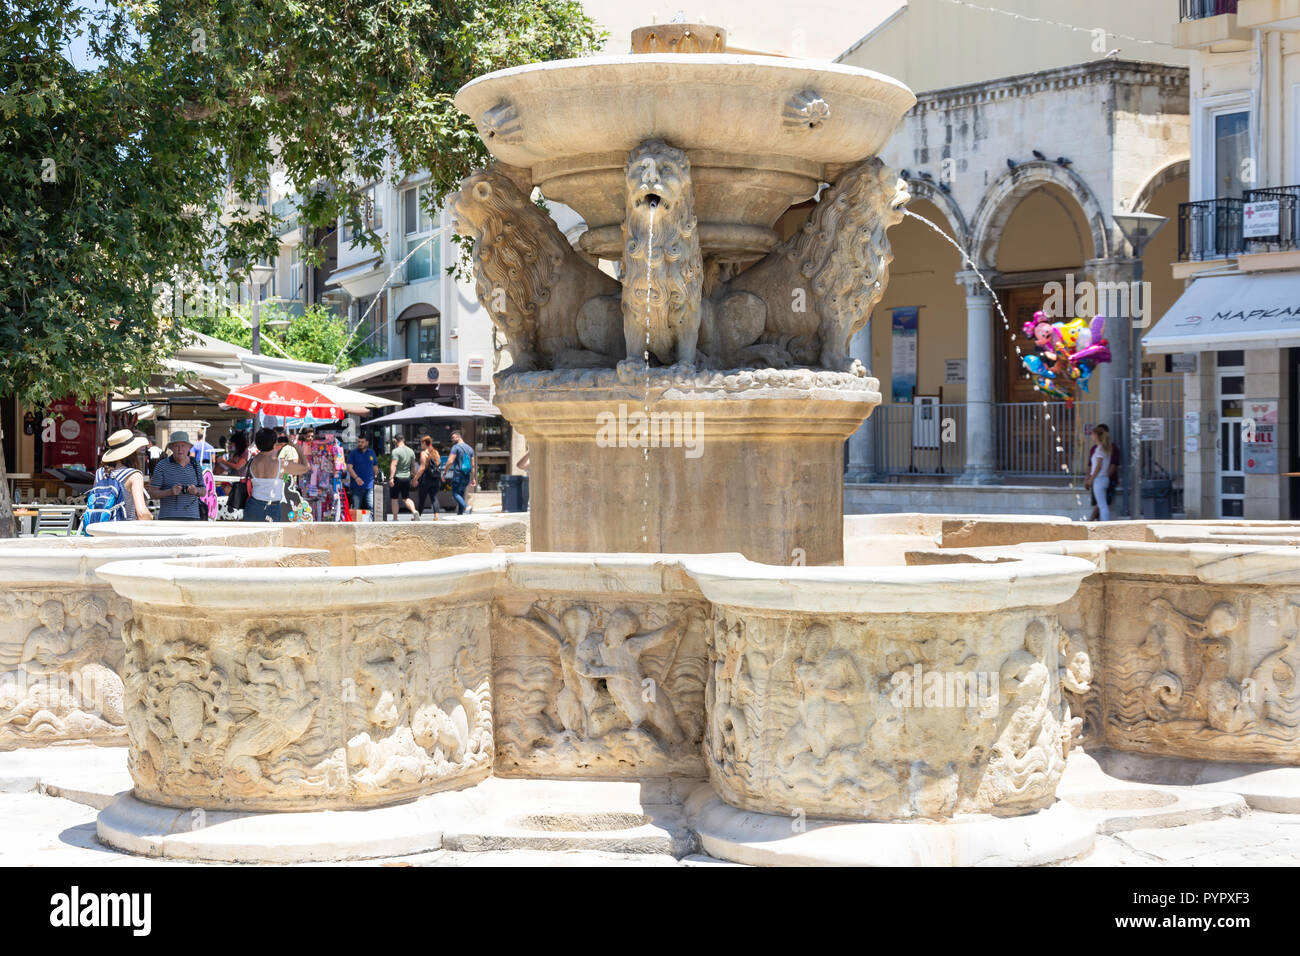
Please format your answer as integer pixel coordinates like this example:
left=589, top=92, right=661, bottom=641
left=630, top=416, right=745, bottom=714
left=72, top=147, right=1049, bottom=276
left=0, top=747, right=1300, bottom=866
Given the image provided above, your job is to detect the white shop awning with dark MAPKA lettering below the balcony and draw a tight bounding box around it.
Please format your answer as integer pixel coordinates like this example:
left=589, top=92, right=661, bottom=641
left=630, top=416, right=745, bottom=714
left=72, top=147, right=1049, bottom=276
left=1141, top=272, right=1300, bottom=352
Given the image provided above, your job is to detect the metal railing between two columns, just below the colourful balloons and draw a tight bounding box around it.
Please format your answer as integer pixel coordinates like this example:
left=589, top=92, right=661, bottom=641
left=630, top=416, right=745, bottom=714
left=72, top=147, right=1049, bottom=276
left=993, top=402, right=1097, bottom=477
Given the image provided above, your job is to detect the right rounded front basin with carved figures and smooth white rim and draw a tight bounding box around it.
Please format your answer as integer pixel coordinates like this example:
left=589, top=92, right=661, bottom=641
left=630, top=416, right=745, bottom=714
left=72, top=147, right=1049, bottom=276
left=685, top=558, right=1087, bottom=821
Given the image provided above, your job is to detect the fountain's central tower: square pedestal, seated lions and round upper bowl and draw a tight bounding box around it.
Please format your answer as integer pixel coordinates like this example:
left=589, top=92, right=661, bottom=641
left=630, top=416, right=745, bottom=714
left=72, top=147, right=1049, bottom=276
left=455, top=25, right=915, bottom=564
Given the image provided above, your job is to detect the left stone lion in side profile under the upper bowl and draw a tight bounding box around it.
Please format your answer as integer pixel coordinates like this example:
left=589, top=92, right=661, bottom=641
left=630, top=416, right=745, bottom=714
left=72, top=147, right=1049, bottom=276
left=452, top=168, right=623, bottom=375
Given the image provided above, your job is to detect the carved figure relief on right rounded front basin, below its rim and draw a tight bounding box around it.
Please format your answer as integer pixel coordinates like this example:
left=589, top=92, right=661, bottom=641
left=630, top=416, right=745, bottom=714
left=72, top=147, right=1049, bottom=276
left=706, top=607, right=1089, bottom=819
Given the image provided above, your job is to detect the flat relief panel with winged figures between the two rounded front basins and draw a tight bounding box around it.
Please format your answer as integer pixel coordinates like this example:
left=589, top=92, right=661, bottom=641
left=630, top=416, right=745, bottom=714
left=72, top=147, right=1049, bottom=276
left=493, top=598, right=707, bottom=777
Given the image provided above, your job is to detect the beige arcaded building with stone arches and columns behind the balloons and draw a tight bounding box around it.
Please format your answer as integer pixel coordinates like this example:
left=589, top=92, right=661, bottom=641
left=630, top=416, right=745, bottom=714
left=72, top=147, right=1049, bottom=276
left=842, top=0, right=1191, bottom=516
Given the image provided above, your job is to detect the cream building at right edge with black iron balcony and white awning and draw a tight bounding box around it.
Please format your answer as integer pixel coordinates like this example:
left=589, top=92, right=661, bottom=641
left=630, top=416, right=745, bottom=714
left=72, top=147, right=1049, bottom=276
left=1144, top=0, right=1300, bottom=519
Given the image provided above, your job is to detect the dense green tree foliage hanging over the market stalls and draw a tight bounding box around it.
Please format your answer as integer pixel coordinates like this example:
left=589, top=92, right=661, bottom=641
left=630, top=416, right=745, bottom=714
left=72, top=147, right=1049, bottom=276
left=0, top=0, right=602, bottom=405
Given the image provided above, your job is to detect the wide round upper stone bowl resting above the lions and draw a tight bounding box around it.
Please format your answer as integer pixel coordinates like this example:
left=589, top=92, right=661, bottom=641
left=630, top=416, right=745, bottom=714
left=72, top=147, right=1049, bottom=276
left=455, top=53, right=917, bottom=258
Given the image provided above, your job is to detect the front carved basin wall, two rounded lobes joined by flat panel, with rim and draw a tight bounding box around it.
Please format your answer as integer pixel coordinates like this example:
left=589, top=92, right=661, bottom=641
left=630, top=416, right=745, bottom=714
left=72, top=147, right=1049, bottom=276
left=86, top=554, right=1092, bottom=819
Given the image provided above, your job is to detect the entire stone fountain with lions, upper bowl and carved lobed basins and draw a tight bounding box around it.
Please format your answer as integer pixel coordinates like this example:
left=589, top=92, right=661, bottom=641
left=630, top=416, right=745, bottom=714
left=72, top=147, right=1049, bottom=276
left=17, top=25, right=1248, bottom=864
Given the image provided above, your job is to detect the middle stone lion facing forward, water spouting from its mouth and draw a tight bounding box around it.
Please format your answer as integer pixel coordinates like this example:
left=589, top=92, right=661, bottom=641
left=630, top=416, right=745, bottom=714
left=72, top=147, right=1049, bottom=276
left=623, top=139, right=705, bottom=365
